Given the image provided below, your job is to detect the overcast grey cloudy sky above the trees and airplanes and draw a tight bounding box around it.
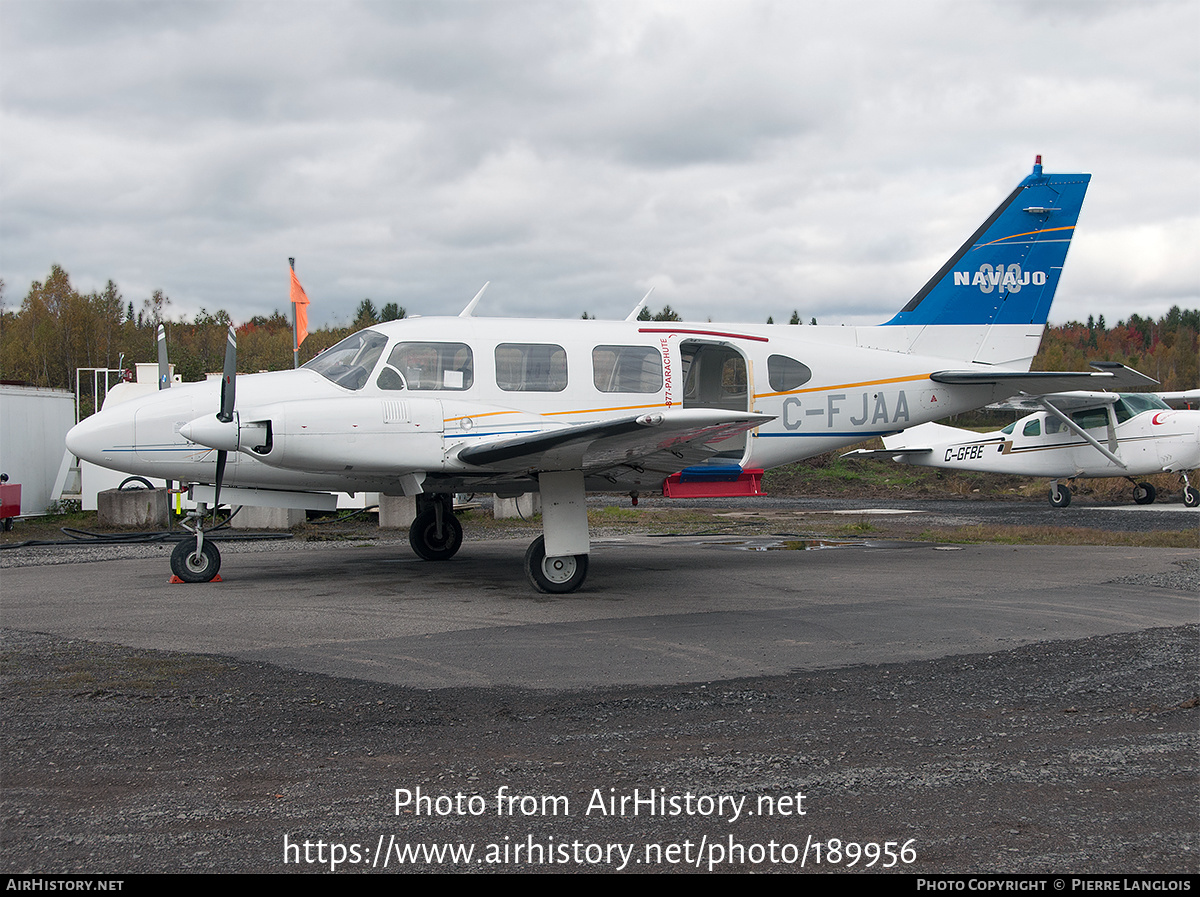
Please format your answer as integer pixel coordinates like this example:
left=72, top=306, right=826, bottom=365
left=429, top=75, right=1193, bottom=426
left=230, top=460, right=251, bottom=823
left=0, top=0, right=1200, bottom=325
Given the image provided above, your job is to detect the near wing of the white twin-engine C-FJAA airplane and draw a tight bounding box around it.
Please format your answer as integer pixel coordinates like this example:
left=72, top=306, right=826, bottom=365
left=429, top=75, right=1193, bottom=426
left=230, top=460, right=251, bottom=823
left=458, top=408, right=774, bottom=476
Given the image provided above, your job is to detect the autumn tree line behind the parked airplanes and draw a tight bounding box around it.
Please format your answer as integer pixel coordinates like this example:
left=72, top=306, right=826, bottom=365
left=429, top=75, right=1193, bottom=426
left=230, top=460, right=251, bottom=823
left=0, top=265, right=1200, bottom=390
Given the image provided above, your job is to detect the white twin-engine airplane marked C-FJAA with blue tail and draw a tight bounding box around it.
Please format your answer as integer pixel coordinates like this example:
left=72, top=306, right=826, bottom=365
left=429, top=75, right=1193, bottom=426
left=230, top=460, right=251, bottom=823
left=67, top=157, right=1112, bottom=592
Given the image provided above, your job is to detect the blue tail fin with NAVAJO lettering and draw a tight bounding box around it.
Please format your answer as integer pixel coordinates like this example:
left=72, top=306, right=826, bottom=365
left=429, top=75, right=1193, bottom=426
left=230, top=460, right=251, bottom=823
left=887, top=156, right=1092, bottom=325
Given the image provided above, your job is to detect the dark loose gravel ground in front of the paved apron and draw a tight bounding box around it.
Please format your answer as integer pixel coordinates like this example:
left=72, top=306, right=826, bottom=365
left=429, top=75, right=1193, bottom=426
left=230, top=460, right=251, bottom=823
left=0, top=626, right=1200, bottom=875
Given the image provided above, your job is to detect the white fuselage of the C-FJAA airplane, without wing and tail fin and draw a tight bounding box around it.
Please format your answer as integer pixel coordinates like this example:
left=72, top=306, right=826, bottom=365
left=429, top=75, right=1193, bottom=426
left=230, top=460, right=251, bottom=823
left=70, top=318, right=1022, bottom=494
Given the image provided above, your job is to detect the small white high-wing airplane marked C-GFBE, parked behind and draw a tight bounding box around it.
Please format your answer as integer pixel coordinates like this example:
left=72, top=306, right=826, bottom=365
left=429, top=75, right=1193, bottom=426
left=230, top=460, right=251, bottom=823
left=845, top=383, right=1200, bottom=507
